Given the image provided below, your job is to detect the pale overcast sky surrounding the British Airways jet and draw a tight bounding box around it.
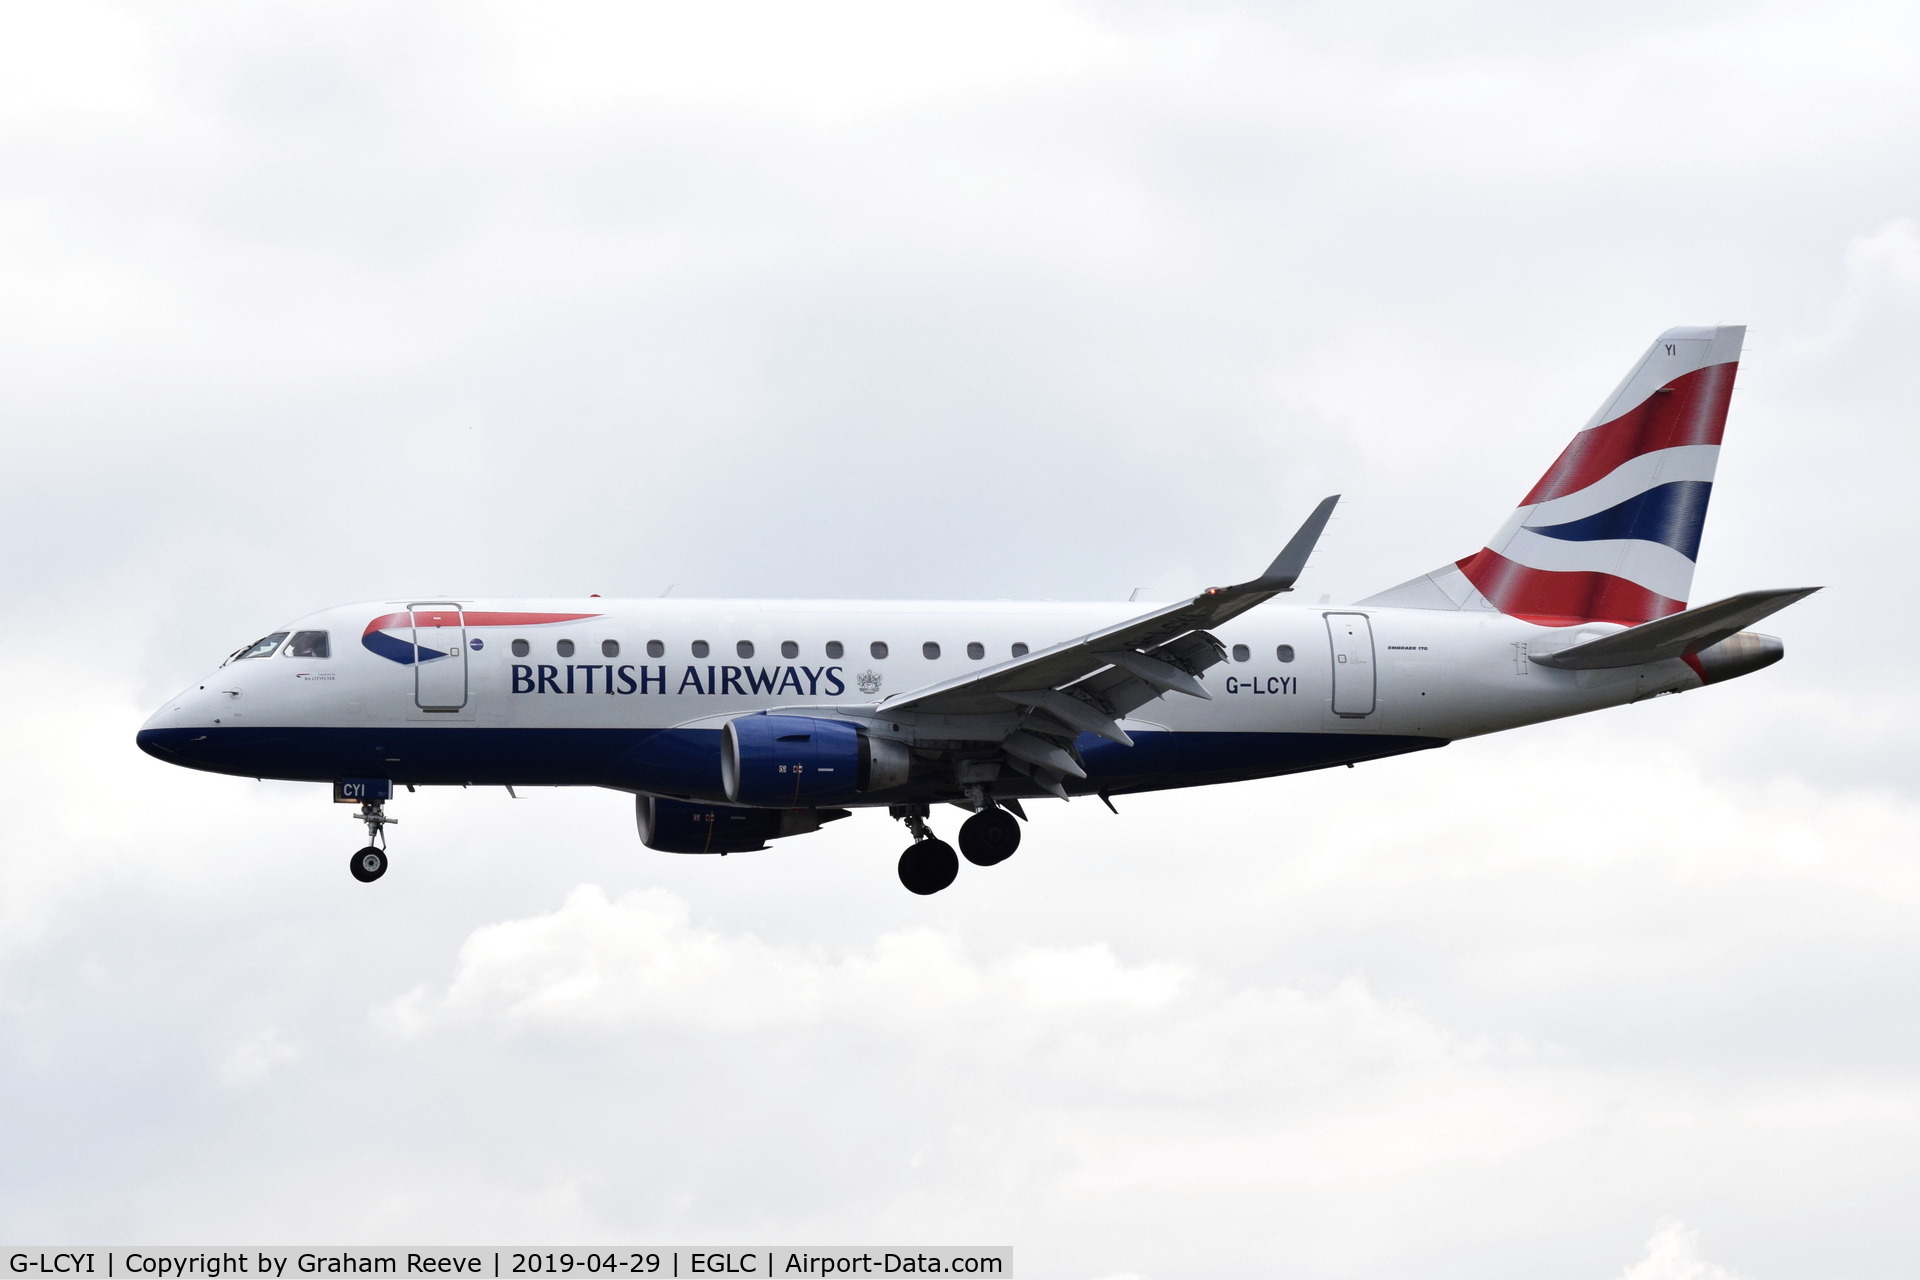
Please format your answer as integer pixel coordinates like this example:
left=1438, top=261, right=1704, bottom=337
left=0, top=0, right=1920, bottom=1280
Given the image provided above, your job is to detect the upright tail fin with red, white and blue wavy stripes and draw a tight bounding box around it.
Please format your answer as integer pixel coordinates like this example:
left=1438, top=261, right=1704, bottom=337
left=1359, top=324, right=1747, bottom=626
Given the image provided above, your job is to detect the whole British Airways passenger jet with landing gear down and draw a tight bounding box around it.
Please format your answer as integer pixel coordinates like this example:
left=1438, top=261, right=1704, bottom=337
left=136, top=324, right=1818, bottom=894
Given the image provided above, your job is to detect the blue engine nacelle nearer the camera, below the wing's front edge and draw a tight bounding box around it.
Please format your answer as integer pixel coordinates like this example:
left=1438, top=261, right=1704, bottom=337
left=720, top=716, right=912, bottom=808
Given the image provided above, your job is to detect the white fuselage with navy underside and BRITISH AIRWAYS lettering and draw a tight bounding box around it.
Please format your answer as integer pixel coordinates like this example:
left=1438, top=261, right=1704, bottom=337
left=140, top=597, right=1701, bottom=804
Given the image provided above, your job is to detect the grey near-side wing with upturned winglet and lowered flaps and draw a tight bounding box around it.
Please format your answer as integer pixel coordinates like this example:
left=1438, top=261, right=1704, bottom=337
left=876, top=493, right=1340, bottom=756
